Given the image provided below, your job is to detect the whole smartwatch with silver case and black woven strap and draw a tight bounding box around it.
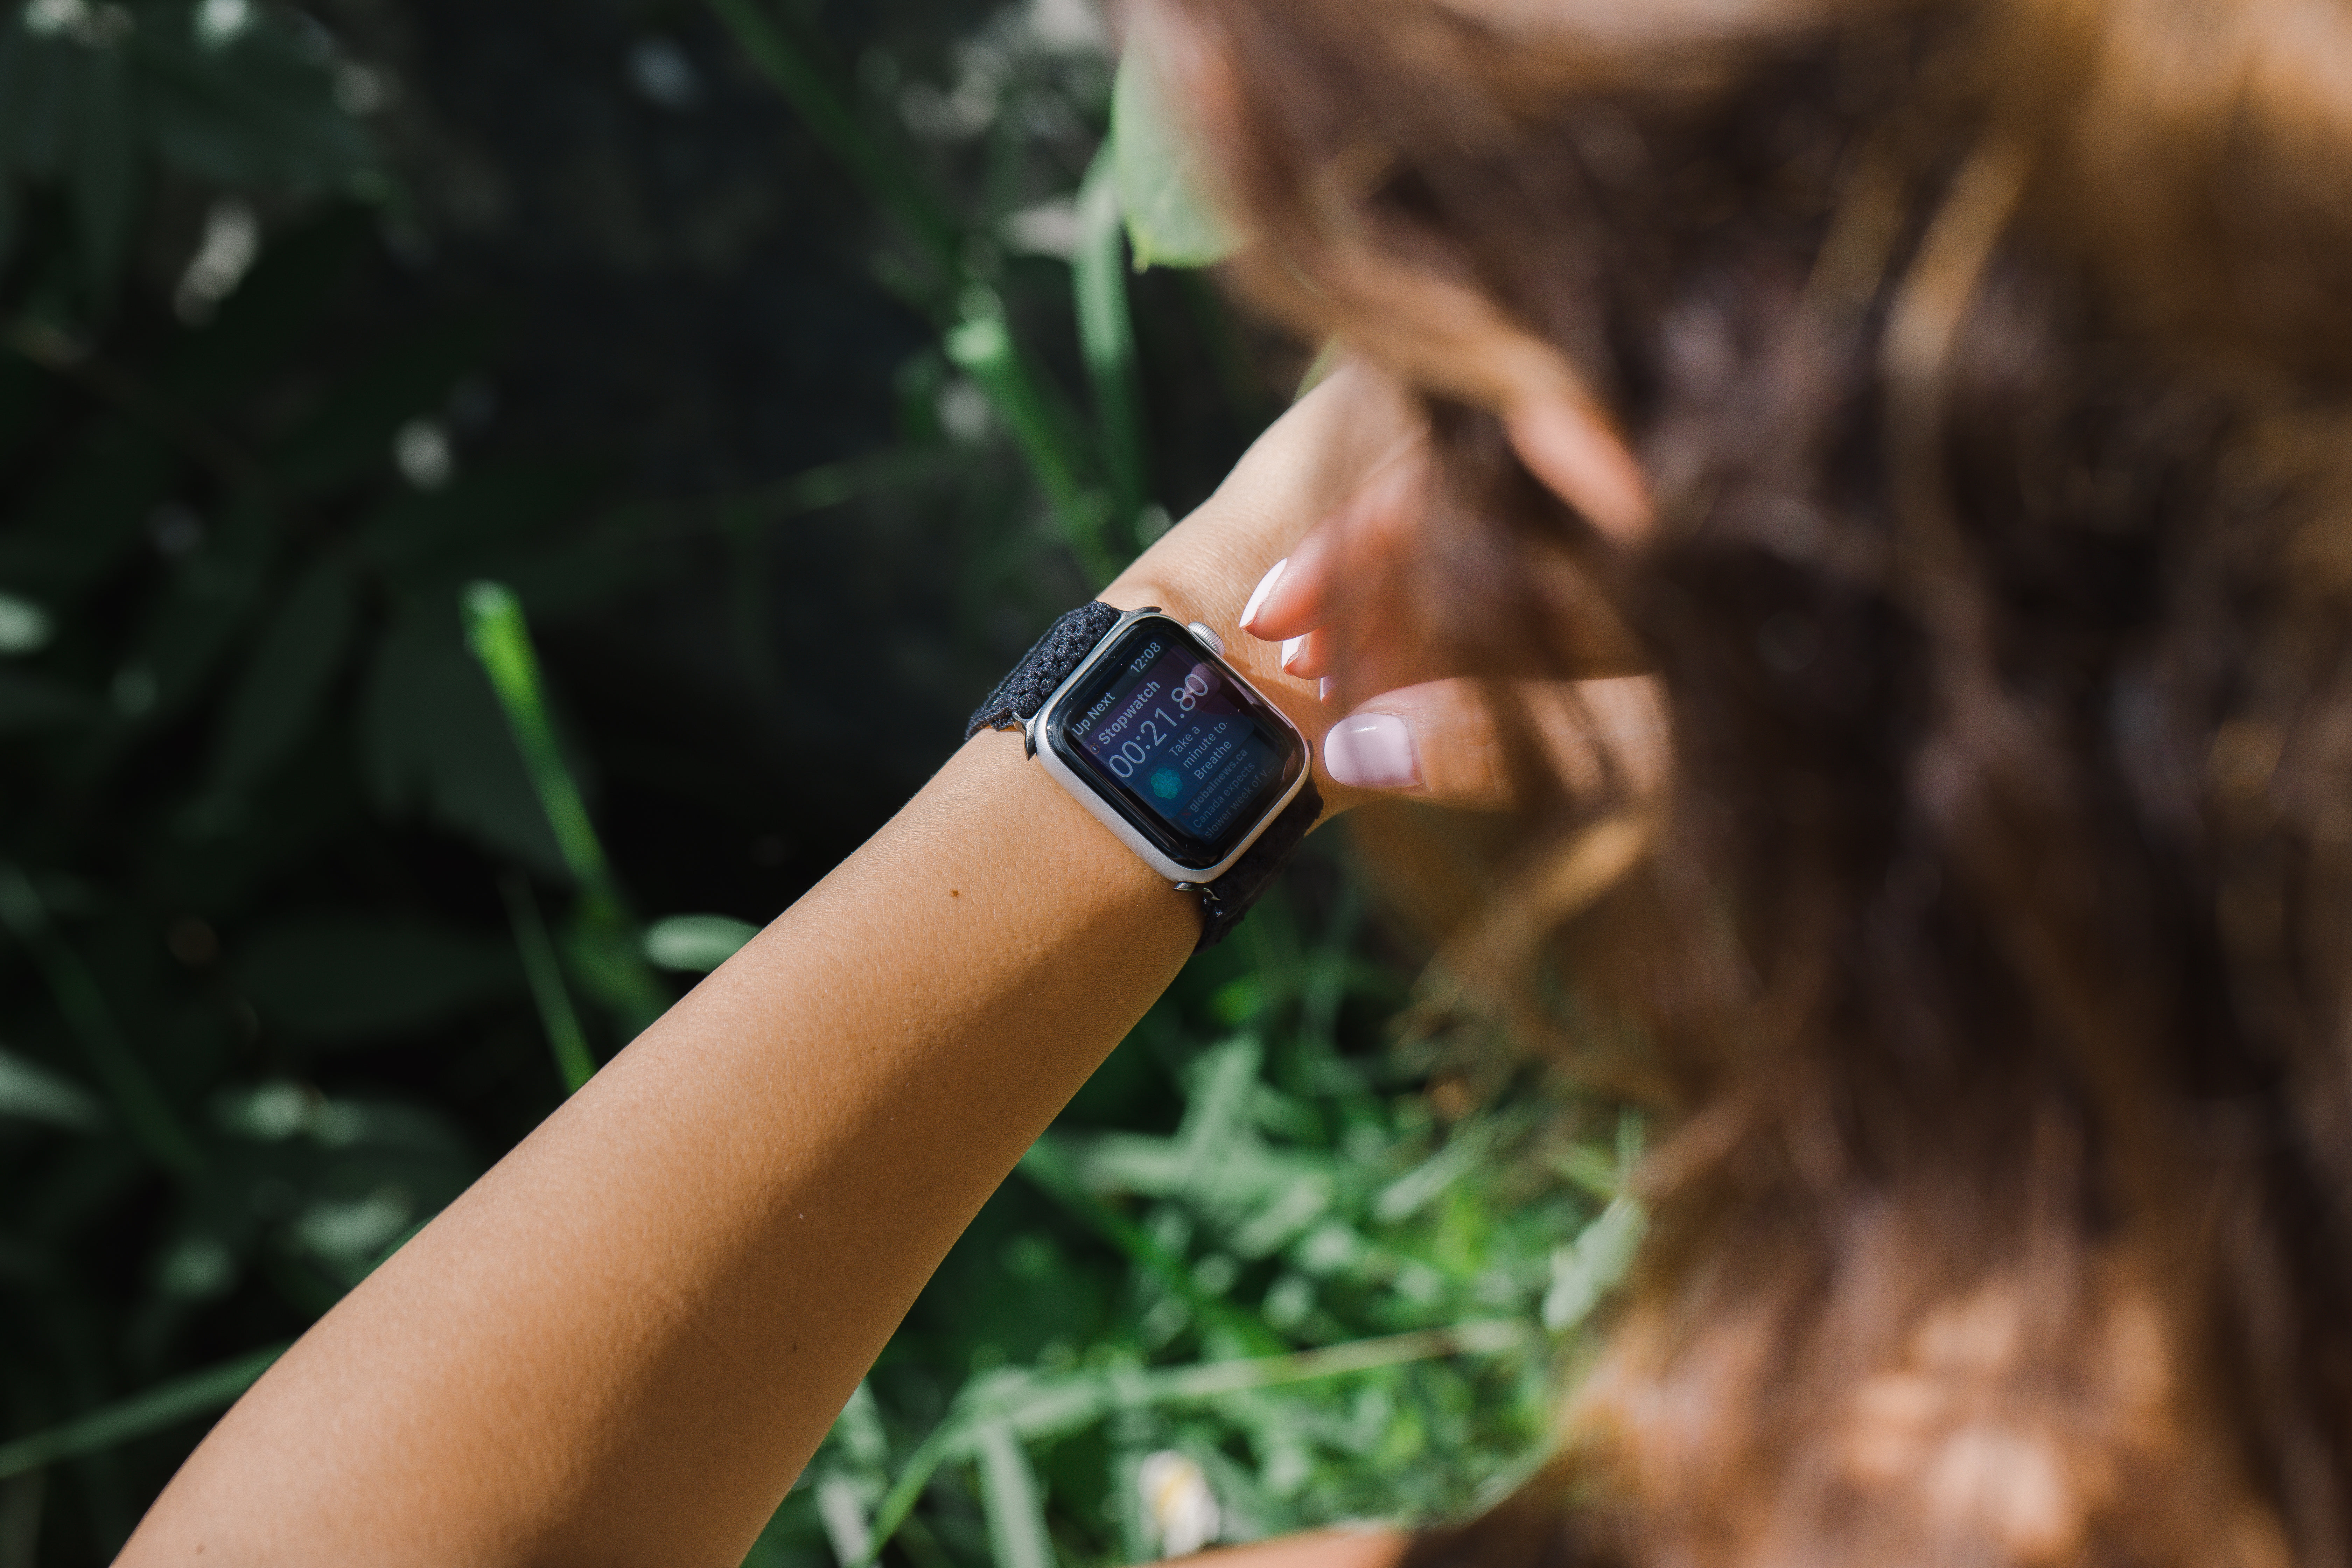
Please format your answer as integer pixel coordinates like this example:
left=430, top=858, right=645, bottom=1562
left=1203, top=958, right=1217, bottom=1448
left=964, top=602, right=1322, bottom=952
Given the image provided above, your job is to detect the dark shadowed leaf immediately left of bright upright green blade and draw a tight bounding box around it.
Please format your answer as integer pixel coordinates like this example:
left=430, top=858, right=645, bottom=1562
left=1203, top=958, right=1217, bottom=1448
left=360, top=602, right=572, bottom=886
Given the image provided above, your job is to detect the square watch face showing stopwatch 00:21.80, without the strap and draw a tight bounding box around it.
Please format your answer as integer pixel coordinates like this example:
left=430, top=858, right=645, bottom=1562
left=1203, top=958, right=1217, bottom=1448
left=1044, top=616, right=1308, bottom=867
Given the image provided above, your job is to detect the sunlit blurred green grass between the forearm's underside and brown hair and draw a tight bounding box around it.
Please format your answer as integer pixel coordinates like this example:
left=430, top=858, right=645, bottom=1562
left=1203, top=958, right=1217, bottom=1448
left=752, top=959, right=1639, bottom=1568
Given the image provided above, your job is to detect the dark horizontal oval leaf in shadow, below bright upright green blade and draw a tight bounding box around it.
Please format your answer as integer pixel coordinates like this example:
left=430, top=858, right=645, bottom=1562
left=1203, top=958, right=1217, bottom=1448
left=233, top=912, right=522, bottom=1041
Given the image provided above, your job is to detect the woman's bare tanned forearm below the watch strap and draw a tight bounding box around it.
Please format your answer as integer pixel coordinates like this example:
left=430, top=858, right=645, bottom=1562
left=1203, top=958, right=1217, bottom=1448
left=125, top=734, right=1199, bottom=1563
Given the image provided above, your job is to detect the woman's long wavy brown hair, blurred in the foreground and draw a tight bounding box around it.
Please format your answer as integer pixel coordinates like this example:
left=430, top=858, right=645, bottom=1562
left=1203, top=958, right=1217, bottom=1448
left=1164, top=0, right=2352, bottom=1568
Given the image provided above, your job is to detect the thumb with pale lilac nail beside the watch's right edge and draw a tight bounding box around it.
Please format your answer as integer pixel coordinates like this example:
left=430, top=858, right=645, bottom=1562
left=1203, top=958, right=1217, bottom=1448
left=1322, top=675, right=1667, bottom=811
